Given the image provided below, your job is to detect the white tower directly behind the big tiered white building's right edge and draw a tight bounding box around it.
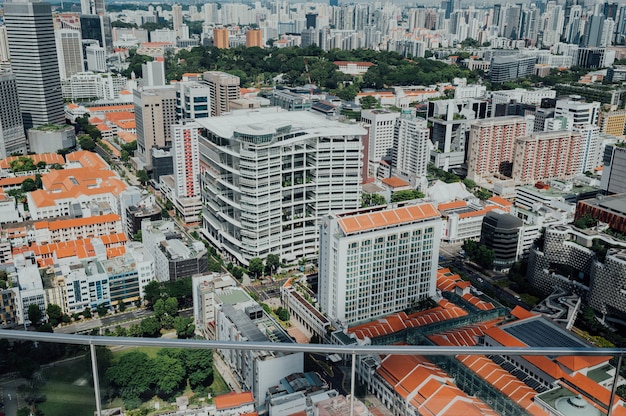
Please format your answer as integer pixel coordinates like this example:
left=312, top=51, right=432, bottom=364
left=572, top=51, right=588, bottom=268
left=361, top=109, right=400, bottom=162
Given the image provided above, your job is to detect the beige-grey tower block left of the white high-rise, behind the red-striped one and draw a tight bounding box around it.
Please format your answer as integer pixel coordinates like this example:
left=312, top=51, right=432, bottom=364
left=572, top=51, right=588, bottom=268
left=133, top=86, right=176, bottom=170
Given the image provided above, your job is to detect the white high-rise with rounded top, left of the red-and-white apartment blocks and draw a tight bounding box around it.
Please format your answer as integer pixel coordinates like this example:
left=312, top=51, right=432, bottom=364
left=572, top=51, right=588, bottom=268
left=393, top=110, right=432, bottom=178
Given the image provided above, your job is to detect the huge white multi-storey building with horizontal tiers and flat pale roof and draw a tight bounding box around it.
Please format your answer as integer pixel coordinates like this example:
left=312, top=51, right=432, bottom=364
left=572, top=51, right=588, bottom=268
left=196, top=107, right=366, bottom=264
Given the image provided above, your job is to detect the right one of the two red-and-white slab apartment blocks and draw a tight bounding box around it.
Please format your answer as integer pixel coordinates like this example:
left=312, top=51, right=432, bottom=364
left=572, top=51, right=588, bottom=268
left=512, top=130, right=582, bottom=184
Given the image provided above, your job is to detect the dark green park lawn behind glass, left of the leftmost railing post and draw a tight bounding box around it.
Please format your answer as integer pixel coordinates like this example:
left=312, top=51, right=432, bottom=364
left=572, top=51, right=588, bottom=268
left=37, top=360, right=96, bottom=416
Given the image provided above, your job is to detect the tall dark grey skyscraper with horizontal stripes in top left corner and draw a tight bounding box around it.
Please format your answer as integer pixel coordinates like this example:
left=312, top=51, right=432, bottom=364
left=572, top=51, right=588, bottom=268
left=4, top=1, right=65, bottom=129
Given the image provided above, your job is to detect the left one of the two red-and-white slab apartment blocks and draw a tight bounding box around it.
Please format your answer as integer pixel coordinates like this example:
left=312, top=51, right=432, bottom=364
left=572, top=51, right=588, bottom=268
left=467, top=116, right=526, bottom=180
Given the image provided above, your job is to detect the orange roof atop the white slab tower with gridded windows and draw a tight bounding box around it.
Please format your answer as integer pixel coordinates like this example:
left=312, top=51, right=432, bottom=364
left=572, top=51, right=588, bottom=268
left=339, top=203, right=440, bottom=234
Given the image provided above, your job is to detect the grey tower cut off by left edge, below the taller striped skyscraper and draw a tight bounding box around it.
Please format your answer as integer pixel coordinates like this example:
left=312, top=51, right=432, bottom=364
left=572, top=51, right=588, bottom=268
left=0, top=70, right=27, bottom=159
